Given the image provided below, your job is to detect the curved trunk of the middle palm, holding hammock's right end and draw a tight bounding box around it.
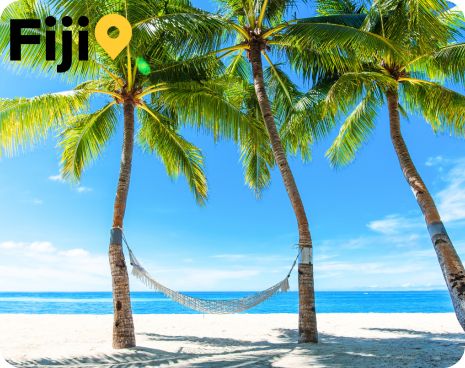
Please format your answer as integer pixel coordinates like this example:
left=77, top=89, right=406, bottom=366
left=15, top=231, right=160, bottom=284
left=249, top=42, right=318, bottom=343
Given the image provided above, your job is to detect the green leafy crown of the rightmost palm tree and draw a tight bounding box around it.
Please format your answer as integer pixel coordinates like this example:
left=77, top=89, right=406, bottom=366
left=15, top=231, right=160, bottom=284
left=323, top=0, right=465, bottom=165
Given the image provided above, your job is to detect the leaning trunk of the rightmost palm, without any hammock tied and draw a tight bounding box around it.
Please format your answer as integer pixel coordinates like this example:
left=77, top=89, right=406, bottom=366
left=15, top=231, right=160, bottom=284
left=387, top=90, right=465, bottom=330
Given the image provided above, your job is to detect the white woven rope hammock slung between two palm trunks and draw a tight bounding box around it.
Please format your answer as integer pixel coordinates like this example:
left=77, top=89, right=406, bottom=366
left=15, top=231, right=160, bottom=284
left=122, top=233, right=300, bottom=314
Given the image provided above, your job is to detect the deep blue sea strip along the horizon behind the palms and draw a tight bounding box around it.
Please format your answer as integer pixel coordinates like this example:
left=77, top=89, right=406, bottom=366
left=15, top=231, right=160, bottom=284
left=0, top=291, right=453, bottom=314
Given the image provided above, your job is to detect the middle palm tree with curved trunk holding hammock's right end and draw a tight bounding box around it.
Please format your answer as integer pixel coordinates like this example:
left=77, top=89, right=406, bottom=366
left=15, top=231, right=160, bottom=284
left=170, top=0, right=394, bottom=342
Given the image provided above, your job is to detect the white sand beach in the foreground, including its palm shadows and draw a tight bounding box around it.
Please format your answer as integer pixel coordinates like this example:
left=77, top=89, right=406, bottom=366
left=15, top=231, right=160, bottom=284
left=0, top=314, right=465, bottom=368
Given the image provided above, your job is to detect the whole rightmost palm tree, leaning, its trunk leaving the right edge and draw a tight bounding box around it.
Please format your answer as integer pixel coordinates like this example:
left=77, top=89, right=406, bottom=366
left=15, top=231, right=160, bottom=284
left=308, top=0, right=465, bottom=330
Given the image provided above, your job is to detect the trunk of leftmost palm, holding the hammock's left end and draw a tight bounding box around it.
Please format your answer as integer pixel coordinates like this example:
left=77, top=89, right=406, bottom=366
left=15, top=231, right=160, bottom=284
left=109, top=101, right=136, bottom=349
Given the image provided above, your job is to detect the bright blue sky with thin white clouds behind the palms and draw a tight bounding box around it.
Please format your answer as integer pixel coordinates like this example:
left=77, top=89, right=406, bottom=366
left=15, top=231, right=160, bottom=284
left=0, top=0, right=465, bottom=291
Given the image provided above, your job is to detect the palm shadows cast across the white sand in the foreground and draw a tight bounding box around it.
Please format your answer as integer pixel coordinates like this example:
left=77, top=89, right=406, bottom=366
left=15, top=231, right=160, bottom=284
left=10, top=329, right=465, bottom=368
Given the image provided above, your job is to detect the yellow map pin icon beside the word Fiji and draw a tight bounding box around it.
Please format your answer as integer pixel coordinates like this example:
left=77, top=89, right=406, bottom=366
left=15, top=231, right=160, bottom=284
left=95, top=14, right=132, bottom=60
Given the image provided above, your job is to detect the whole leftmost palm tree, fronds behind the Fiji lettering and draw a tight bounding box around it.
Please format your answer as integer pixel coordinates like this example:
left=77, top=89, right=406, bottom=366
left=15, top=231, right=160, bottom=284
left=0, top=0, right=253, bottom=349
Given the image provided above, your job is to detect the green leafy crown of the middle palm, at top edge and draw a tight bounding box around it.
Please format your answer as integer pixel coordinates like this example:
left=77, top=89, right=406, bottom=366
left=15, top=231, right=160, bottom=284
left=187, top=0, right=396, bottom=90
